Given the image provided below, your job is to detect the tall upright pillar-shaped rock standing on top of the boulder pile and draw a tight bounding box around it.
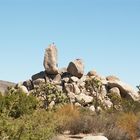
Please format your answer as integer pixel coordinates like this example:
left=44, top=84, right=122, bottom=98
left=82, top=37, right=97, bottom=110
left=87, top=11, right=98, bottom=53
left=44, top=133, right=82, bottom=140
left=44, top=44, right=58, bottom=74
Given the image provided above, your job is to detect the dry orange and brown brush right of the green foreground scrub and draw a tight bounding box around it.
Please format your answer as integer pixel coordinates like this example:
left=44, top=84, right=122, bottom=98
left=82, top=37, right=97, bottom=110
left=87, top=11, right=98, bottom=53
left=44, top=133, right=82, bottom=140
left=55, top=105, right=139, bottom=140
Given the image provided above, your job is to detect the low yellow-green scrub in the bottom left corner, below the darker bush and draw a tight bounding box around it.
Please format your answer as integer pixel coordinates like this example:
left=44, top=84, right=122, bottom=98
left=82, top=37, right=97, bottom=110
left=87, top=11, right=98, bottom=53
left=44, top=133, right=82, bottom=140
left=0, top=110, right=56, bottom=140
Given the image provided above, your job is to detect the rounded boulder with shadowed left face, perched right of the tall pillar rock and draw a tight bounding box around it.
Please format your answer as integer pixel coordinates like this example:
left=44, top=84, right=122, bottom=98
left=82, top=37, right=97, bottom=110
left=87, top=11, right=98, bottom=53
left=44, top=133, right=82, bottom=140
left=67, top=59, right=84, bottom=78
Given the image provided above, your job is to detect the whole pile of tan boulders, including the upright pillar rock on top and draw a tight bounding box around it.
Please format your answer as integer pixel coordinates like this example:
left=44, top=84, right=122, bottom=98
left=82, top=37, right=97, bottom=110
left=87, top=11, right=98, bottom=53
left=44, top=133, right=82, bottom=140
left=20, top=44, right=139, bottom=111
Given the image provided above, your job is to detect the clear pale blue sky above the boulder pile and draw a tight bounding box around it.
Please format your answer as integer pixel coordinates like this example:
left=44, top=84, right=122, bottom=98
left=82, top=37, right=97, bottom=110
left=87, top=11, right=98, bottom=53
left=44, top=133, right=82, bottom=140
left=0, top=0, right=140, bottom=86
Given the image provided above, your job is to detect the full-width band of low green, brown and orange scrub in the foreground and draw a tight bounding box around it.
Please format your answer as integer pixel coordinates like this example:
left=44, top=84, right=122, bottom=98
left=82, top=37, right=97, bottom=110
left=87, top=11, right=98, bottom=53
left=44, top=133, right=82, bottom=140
left=0, top=104, right=140, bottom=140
